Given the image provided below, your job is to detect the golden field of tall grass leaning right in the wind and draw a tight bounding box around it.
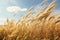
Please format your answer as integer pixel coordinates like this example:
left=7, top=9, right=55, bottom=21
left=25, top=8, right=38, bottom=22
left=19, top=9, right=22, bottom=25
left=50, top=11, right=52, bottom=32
left=0, top=2, right=60, bottom=40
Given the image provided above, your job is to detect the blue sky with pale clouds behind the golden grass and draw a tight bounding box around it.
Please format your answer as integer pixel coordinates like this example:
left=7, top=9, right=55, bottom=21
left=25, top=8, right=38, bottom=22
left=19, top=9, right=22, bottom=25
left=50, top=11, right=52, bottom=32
left=0, top=0, right=60, bottom=24
